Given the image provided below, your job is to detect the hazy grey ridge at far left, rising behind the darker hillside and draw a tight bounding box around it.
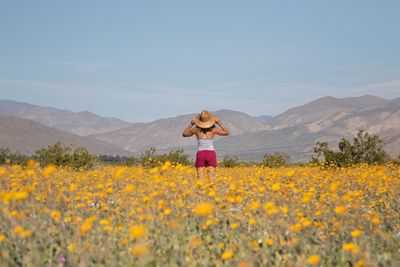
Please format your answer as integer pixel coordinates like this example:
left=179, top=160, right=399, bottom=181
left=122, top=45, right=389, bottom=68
left=0, top=100, right=130, bottom=136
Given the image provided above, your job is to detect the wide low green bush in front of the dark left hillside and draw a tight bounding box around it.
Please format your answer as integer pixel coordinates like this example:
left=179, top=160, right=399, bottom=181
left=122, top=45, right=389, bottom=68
left=36, top=142, right=95, bottom=170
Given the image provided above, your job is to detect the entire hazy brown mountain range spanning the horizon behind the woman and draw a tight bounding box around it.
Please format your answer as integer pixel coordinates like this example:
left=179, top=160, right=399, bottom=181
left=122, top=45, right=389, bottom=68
left=0, top=96, right=400, bottom=161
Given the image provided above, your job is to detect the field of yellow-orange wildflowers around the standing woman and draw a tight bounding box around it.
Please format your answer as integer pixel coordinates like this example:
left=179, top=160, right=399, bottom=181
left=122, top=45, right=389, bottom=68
left=0, top=162, right=400, bottom=266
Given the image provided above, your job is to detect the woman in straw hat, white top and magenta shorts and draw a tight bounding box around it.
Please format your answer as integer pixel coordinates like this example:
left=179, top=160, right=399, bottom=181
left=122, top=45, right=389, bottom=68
left=183, top=110, right=229, bottom=180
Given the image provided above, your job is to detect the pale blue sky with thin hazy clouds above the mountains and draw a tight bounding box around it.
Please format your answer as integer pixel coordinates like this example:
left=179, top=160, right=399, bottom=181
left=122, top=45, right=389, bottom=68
left=0, top=0, right=400, bottom=122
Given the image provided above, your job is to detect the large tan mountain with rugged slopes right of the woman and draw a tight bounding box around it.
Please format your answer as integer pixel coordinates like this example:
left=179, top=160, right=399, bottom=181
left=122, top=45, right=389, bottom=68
left=216, top=96, right=400, bottom=160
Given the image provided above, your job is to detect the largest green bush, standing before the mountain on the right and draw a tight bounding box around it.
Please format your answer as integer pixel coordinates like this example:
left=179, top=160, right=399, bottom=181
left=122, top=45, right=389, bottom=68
left=313, top=130, right=390, bottom=167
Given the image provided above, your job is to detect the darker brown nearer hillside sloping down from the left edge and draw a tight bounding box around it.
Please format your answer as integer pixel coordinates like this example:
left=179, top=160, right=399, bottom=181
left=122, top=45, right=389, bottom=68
left=0, top=115, right=129, bottom=155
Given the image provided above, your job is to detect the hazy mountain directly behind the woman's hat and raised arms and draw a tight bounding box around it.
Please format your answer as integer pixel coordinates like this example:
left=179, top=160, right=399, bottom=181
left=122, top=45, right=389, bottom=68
left=92, top=110, right=266, bottom=152
